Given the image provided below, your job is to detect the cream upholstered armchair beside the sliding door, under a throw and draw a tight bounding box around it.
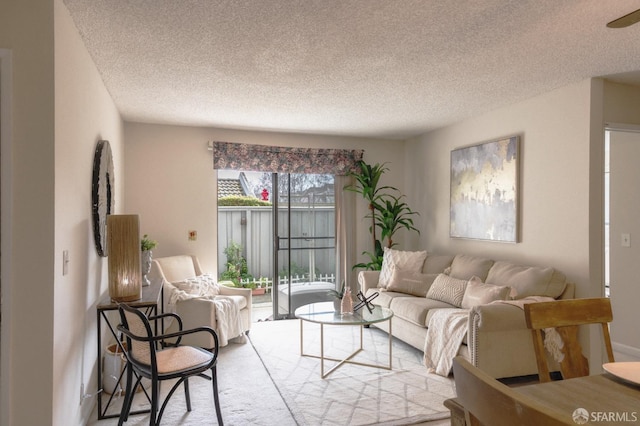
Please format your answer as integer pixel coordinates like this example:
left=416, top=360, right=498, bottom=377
left=149, top=255, right=251, bottom=347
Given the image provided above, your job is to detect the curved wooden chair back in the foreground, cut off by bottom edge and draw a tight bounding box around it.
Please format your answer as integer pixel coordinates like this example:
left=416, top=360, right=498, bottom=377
left=453, top=356, right=576, bottom=426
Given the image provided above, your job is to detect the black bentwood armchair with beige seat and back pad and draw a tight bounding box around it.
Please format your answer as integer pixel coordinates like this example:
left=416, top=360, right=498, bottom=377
left=118, top=304, right=223, bottom=426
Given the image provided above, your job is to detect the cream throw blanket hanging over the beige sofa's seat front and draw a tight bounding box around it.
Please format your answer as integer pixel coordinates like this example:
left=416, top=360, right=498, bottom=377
left=424, top=308, right=469, bottom=377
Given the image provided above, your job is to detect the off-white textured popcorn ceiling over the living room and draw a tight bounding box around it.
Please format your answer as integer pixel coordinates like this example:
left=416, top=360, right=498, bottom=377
left=64, top=0, right=640, bottom=138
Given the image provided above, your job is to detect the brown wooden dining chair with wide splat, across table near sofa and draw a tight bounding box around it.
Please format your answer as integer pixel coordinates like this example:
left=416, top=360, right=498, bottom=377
left=524, top=297, right=614, bottom=382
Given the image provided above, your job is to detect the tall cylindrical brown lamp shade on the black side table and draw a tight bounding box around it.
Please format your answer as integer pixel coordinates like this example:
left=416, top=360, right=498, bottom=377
left=107, top=214, right=142, bottom=302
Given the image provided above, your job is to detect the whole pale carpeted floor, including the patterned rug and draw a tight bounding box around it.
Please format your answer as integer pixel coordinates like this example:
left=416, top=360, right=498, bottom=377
left=88, top=320, right=455, bottom=426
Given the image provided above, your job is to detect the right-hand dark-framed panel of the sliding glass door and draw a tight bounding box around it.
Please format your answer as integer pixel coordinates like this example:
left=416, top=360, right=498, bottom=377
left=272, top=173, right=337, bottom=319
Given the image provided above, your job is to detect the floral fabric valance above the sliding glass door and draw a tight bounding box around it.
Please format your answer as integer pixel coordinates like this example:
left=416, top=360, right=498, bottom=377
left=213, top=142, right=364, bottom=175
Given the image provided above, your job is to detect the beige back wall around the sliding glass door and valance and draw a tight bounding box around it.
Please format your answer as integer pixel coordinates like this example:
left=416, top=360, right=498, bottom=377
left=125, top=123, right=404, bottom=271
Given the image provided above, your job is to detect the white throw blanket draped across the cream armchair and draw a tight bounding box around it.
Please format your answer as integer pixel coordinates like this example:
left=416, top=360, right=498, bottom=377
left=169, top=286, right=246, bottom=346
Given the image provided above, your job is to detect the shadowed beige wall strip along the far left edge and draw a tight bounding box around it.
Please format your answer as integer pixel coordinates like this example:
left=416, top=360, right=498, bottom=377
left=0, top=0, right=54, bottom=425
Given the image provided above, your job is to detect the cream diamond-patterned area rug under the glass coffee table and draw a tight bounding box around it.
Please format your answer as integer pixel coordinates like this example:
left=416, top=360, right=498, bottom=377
left=250, top=320, right=455, bottom=426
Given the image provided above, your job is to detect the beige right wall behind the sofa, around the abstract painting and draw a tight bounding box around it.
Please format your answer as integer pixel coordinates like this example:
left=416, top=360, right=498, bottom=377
left=405, top=81, right=591, bottom=295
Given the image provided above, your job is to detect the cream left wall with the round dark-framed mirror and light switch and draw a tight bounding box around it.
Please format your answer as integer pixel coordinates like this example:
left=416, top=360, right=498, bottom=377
left=52, top=0, right=125, bottom=425
